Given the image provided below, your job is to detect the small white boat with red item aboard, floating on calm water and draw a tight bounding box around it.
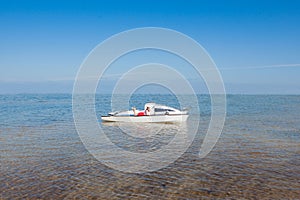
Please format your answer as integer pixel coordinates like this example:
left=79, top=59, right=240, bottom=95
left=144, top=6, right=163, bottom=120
left=101, top=103, right=188, bottom=123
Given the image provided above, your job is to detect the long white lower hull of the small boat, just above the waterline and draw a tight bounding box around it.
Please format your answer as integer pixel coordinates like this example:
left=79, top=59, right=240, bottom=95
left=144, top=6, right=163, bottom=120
left=101, top=115, right=188, bottom=123
